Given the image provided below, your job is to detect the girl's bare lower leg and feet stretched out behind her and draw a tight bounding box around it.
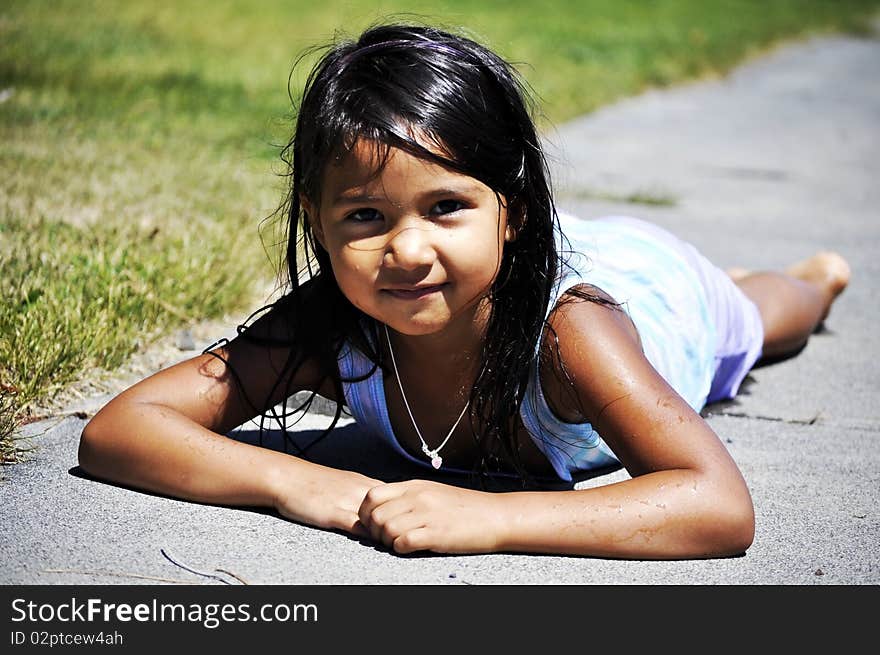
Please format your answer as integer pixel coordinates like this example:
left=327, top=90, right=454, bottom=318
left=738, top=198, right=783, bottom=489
left=728, top=252, right=850, bottom=357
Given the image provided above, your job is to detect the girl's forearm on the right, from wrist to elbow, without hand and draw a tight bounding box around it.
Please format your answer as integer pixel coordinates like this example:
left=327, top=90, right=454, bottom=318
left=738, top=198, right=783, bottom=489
left=499, top=471, right=754, bottom=559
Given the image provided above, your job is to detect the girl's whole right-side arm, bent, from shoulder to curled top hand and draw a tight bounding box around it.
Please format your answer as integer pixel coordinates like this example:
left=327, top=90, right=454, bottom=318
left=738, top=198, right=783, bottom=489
left=360, top=294, right=754, bottom=559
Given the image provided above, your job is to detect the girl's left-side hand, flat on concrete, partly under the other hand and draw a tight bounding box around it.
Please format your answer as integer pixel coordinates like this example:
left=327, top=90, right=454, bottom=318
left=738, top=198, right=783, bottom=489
left=275, top=466, right=384, bottom=538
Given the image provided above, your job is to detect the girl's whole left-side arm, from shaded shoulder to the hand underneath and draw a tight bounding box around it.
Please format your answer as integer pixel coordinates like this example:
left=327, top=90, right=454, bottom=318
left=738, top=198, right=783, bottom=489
left=79, top=302, right=379, bottom=534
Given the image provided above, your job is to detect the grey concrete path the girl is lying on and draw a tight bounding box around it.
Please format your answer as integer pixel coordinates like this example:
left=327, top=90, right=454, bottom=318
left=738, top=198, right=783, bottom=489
left=0, top=28, right=880, bottom=585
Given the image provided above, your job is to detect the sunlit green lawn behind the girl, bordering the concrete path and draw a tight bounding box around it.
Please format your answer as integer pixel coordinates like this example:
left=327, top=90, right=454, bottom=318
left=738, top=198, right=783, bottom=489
left=0, top=0, right=880, bottom=463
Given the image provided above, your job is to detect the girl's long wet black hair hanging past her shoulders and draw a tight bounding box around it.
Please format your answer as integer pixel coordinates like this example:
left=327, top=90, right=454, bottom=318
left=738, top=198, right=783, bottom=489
left=230, top=24, right=596, bottom=480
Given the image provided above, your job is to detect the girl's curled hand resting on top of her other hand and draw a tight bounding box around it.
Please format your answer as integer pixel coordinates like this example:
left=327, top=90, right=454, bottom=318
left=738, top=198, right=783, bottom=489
left=358, top=480, right=503, bottom=553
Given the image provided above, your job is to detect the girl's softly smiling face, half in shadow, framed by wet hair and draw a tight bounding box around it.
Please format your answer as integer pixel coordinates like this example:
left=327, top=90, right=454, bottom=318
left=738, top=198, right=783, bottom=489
left=303, top=141, right=513, bottom=335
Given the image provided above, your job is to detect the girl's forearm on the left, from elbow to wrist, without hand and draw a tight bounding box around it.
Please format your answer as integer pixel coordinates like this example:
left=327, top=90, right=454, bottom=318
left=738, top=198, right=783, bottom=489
left=79, top=400, right=312, bottom=506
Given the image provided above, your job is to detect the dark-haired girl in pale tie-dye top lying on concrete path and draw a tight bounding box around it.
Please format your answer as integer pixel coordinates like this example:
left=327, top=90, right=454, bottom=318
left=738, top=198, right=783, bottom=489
left=79, top=25, right=849, bottom=558
